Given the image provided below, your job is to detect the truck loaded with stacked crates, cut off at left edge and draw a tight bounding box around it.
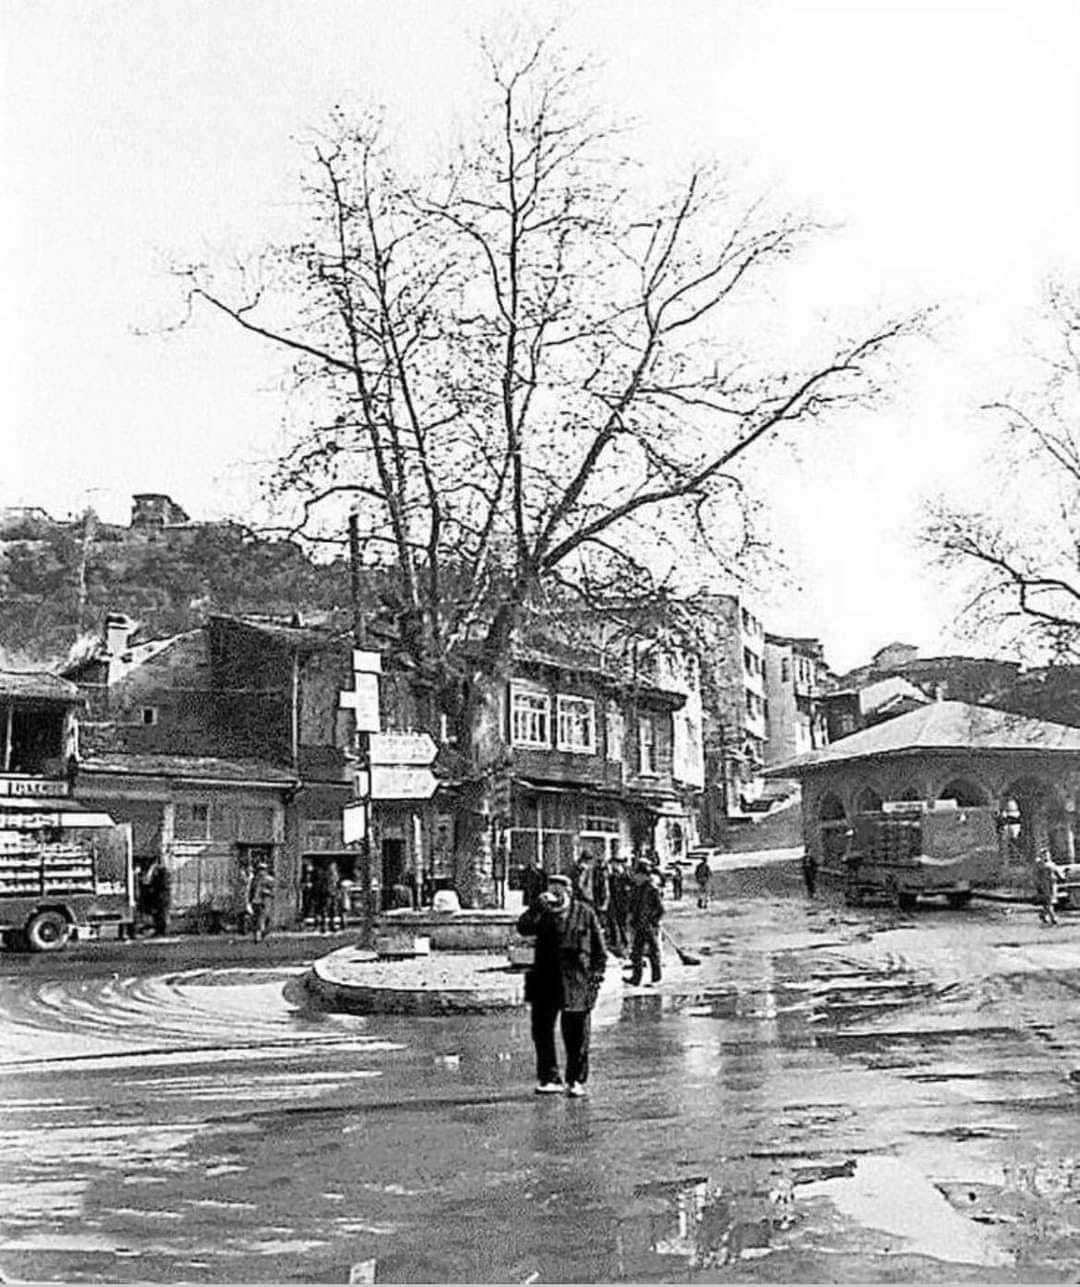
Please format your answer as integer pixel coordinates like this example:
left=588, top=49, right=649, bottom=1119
left=0, top=801, right=135, bottom=952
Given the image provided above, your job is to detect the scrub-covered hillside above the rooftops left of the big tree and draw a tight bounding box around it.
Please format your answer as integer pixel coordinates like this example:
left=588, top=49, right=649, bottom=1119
left=0, top=510, right=350, bottom=668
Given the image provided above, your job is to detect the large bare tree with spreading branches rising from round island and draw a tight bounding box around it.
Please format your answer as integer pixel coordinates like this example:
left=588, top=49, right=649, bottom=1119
left=177, top=39, right=917, bottom=900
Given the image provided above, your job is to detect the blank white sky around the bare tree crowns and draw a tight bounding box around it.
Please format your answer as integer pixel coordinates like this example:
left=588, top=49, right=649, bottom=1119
left=0, top=0, right=1080, bottom=669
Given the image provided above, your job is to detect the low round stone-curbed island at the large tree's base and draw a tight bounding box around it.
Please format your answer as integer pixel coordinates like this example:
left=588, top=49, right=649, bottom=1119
left=304, top=947, right=622, bottom=1015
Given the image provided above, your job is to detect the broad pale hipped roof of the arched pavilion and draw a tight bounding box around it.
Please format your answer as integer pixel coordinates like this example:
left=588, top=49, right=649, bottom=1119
left=766, top=701, right=1080, bottom=777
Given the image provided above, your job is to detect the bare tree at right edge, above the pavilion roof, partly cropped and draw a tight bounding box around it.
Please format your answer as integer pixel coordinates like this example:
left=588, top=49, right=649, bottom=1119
left=924, top=284, right=1080, bottom=660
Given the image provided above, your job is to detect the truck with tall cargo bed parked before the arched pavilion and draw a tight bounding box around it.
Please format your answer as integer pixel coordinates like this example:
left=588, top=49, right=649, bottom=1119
left=843, top=801, right=1003, bottom=910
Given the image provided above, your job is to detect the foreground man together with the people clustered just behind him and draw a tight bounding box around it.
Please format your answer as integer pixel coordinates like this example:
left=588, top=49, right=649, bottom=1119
left=517, top=856, right=684, bottom=1098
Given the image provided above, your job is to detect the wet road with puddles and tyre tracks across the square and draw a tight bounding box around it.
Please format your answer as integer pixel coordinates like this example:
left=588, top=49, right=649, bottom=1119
left=0, top=900, right=1080, bottom=1282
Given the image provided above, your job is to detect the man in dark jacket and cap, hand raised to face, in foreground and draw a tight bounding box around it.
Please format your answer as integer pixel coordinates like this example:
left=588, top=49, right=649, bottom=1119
left=517, top=875, right=608, bottom=1098
